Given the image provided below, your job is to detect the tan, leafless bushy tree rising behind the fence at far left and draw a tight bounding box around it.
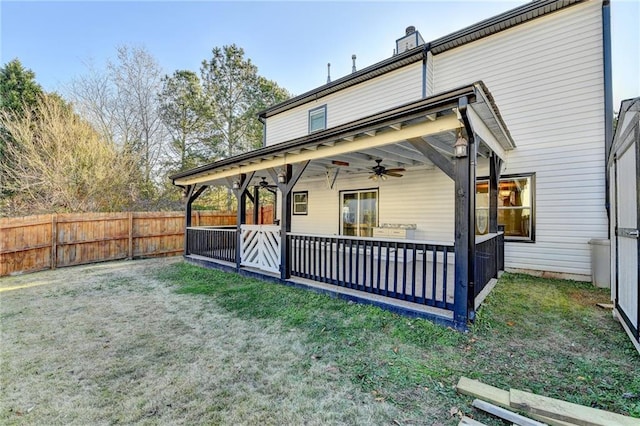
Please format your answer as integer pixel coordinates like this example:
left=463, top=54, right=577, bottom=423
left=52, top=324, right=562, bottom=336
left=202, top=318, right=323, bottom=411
left=0, top=95, right=137, bottom=214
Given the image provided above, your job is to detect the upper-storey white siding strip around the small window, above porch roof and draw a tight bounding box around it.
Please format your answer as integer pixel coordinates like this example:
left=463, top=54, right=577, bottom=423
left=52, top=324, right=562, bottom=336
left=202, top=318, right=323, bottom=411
left=266, top=62, right=422, bottom=145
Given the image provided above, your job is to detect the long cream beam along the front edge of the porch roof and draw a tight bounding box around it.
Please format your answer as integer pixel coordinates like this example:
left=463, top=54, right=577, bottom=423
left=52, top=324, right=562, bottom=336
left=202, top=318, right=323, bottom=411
left=175, top=114, right=460, bottom=185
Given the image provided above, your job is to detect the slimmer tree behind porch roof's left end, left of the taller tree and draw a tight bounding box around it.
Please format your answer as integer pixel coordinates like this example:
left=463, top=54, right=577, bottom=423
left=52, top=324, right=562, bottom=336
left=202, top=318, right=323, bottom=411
left=159, top=70, right=214, bottom=174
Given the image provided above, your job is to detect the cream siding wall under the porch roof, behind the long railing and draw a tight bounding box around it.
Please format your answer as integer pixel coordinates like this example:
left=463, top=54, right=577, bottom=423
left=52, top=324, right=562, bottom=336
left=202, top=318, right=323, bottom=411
left=291, top=169, right=454, bottom=242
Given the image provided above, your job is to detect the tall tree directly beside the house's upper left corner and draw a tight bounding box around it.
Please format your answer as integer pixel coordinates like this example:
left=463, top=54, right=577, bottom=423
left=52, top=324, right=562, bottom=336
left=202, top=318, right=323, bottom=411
left=200, top=44, right=289, bottom=157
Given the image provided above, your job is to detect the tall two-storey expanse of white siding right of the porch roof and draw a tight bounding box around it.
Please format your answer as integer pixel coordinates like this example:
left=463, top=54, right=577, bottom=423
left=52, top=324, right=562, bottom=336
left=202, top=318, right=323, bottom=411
left=433, top=1, right=607, bottom=279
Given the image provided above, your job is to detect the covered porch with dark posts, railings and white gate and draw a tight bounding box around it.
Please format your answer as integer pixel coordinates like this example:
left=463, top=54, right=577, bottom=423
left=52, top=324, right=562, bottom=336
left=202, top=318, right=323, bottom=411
left=172, top=83, right=514, bottom=329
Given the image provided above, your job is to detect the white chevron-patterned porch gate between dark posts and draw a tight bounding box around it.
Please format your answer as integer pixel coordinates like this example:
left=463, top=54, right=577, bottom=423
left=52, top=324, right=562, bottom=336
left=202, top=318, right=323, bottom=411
left=240, top=225, right=280, bottom=272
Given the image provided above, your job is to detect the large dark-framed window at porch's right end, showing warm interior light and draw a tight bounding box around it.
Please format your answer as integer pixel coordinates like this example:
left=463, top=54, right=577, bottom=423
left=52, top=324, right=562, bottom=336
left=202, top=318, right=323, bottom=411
left=476, top=175, right=535, bottom=241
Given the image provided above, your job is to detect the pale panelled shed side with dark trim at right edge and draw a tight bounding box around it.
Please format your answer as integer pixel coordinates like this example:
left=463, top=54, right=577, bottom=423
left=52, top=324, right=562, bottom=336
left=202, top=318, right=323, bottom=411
left=609, top=98, right=640, bottom=351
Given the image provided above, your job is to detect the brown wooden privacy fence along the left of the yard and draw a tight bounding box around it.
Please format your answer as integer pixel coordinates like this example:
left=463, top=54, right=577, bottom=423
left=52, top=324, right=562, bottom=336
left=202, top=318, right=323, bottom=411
left=0, top=211, right=238, bottom=276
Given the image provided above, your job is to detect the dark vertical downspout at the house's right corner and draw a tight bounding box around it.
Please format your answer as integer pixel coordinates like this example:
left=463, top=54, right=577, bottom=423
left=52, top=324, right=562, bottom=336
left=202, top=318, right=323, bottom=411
left=602, top=0, right=613, bottom=238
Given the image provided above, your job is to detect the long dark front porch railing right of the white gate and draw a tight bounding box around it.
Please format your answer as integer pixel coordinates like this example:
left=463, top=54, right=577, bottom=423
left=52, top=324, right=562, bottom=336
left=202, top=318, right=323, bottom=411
left=287, top=233, right=454, bottom=310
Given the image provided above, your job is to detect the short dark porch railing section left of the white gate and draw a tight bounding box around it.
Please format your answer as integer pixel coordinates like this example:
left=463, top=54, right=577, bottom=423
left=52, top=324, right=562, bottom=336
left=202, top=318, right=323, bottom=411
left=187, top=226, right=238, bottom=262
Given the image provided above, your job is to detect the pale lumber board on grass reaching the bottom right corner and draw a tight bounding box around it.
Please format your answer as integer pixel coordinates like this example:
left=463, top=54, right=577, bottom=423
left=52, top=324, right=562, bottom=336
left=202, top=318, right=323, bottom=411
left=509, top=389, right=640, bottom=426
